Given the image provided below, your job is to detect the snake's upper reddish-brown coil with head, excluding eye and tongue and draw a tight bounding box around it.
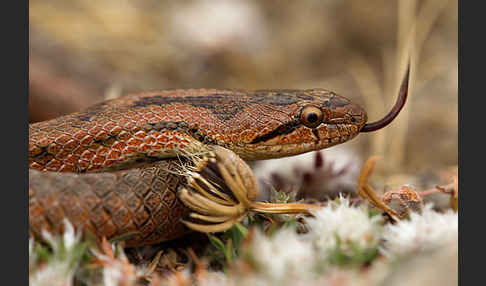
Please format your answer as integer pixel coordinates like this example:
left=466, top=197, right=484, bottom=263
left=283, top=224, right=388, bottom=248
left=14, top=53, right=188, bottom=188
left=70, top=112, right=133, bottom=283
left=29, top=89, right=366, bottom=172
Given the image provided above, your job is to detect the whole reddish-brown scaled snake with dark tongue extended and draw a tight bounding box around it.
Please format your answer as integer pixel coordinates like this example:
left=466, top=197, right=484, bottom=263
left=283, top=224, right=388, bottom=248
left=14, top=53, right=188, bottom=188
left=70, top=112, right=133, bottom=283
left=29, top=66, right=409, bottom=246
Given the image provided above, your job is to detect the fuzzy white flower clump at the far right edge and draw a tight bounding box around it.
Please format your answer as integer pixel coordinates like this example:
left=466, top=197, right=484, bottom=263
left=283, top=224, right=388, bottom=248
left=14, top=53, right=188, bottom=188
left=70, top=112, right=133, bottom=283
left=381, top=204, right=458, bottom=256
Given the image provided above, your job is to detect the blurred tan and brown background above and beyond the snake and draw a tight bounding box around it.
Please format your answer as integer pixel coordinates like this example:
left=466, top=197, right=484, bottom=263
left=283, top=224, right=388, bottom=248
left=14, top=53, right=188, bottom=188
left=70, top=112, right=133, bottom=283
left=29, top=0, right=458, bottom=192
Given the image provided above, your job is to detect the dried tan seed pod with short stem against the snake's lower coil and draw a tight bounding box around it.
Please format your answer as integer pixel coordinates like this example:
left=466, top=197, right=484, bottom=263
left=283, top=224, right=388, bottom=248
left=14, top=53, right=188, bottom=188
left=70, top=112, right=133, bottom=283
left=178, top=147, right=319, bottom=232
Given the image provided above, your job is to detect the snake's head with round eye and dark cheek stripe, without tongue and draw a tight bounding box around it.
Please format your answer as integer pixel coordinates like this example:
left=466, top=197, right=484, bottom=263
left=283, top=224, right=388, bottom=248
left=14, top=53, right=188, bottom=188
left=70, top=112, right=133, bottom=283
left=237, top=89, right=367, bottom=159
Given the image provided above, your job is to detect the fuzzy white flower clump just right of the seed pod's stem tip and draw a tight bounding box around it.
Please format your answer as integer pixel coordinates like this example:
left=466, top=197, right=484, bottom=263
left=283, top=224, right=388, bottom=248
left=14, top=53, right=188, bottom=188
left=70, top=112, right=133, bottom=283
left=305, top=197, right=381, bottom=255
